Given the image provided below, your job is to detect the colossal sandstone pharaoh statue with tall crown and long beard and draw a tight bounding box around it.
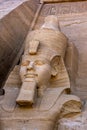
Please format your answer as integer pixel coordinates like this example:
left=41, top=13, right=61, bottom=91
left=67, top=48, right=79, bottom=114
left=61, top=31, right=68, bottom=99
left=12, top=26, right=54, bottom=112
left=0, top=15, right=81, bottom=130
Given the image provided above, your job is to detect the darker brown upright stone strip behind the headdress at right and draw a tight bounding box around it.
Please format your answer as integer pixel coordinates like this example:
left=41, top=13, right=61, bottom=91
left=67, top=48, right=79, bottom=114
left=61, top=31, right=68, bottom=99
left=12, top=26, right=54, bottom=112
left=65, top=43, right=78, bottom=92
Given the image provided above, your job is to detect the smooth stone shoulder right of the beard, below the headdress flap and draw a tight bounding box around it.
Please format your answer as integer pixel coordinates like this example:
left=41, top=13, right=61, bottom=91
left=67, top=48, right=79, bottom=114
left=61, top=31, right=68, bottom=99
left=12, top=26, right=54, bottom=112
left=40, top=87, right=70, bottom=110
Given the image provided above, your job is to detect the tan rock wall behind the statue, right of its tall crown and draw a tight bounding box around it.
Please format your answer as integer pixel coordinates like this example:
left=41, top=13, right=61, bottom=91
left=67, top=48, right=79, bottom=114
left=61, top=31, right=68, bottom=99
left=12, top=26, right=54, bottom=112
left=35, top=1, right=87, bottom=99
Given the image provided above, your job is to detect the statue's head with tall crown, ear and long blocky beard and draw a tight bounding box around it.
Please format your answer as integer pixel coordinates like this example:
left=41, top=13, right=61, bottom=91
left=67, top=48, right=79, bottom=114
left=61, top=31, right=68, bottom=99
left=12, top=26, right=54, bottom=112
left=17, top=16, right=69, bottom=104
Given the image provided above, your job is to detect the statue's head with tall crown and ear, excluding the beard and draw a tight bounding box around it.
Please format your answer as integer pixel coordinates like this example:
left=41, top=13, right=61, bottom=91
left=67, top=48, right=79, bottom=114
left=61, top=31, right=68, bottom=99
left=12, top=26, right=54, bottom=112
left=20, top=16, right=67, bottom=95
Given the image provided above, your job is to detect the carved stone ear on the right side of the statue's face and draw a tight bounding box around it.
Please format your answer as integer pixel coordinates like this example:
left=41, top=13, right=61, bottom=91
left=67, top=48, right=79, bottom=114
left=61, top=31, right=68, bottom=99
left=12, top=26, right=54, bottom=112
left=51, top=55, right=61, bottom=76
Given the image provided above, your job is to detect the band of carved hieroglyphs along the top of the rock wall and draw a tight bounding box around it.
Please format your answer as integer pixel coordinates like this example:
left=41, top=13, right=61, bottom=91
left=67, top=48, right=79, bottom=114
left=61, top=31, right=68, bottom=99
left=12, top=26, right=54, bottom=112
left=41, top=2, right=87, bottom=16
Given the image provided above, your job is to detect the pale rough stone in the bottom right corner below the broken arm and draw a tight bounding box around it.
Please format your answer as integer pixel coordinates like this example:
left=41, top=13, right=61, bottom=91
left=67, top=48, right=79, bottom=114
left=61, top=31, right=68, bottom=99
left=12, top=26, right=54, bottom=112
left=58, top=111, right=87, bottom=130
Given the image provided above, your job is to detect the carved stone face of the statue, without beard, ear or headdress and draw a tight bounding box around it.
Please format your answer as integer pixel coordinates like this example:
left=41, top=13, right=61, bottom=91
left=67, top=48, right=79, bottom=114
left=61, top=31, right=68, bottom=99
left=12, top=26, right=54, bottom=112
left=20, top=58, right=51, bottom=86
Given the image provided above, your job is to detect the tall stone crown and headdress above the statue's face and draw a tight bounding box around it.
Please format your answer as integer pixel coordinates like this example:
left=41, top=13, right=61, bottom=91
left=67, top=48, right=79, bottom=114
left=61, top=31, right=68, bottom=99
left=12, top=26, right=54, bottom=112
left=24, top=15, right=69, bottom=86
